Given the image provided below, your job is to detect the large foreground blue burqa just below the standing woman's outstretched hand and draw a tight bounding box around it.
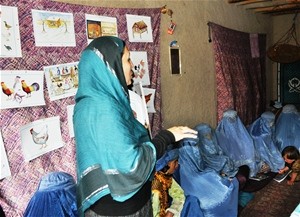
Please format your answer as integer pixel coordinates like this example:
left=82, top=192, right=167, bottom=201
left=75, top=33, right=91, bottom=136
left=179, top=145, right=239, bottom=217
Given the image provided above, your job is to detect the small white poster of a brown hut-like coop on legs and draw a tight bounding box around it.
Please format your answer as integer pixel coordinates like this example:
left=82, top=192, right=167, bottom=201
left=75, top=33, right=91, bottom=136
left=126, top=14, right=153, bottom=42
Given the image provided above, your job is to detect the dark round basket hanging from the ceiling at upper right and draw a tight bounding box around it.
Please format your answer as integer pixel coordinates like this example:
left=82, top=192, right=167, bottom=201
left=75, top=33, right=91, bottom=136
left=267, top=13, right=300, bottom=63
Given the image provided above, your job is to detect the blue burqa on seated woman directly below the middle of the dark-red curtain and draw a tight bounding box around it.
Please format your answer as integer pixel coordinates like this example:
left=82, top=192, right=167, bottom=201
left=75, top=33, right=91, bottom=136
left=215, top=110, right=259, bottom=176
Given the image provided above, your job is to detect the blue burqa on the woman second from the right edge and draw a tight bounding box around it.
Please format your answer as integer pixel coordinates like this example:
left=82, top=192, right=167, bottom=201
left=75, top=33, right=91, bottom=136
left=248, top=111, right=284, bottom=172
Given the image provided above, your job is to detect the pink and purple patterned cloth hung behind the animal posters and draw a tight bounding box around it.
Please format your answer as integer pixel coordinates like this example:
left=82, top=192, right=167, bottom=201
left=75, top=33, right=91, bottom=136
left=0, top=0, right=162, bottom=217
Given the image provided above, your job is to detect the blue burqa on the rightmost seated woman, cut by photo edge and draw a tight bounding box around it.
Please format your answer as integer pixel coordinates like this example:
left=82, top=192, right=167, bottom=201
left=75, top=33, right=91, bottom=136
left=276, top=104, right=300, bottom=151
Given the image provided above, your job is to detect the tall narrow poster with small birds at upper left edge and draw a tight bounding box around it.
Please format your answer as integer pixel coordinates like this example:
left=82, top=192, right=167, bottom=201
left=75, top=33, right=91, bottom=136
left=0, top=5, right=22, bottom=57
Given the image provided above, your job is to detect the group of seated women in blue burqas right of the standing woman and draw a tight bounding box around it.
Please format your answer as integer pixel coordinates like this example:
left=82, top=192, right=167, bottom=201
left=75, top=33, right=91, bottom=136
left=161, top=105, right=300, bottom=217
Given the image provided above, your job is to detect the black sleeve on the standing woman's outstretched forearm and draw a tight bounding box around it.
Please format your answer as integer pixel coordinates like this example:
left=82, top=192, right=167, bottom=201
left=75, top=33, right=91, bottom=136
left=152, top=130, right=175, bottom=159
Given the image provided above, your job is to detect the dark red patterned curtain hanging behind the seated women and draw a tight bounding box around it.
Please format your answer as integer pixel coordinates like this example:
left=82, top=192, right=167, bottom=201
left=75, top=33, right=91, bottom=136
left=208, top=23, right=266, bottom=125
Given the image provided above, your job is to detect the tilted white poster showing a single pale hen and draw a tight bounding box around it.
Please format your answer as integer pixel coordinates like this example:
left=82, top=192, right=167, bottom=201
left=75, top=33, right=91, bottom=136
left=20, top=116, right=64, bottom=162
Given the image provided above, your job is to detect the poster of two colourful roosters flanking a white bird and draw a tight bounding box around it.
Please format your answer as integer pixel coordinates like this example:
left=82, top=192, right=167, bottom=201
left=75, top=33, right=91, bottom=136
left=0, top=70, right=45, bottom=109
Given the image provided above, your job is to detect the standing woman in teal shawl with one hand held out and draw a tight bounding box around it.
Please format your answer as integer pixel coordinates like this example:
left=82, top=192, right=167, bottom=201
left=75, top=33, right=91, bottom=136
left=73, top=36, right=197, bottom=217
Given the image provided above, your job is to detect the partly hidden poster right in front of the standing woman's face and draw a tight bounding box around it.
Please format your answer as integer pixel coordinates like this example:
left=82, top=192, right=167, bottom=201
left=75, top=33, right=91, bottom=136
left=130, top=51, right=150, bottom=85
